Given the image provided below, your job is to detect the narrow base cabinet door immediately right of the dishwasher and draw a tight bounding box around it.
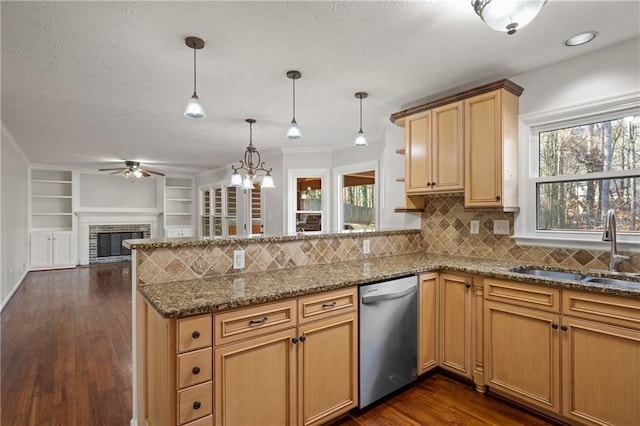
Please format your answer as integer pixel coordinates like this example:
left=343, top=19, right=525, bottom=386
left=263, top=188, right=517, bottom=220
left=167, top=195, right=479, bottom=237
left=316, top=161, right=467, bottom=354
left=418, top=273, right=440, bottom=374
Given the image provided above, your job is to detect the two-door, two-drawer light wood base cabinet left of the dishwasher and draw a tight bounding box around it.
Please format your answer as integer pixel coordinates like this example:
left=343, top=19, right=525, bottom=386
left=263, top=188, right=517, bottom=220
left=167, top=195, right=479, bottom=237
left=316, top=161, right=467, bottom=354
left=214, top=287, right=358, bottom=426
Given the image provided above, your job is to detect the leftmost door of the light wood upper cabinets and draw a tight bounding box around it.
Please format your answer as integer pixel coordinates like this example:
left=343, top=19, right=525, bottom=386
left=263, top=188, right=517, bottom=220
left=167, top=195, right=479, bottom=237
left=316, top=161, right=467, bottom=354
left=404, top=111, right=433, bottom=194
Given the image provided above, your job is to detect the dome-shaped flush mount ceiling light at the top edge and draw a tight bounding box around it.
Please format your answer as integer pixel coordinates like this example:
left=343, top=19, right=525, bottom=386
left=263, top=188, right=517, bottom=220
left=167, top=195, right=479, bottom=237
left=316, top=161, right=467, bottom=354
left=471, top=0, right=547, bottom=34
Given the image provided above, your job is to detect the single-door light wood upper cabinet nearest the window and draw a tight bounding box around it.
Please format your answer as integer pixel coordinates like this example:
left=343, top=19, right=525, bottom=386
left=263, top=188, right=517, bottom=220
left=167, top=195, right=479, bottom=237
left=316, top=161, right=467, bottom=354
left=464, top=89, right=518, bottom=210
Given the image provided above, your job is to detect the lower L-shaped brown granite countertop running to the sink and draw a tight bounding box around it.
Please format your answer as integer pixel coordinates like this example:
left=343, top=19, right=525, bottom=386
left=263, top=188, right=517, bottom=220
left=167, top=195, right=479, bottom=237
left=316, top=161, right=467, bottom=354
left=138, top=253, right=640, bottom=318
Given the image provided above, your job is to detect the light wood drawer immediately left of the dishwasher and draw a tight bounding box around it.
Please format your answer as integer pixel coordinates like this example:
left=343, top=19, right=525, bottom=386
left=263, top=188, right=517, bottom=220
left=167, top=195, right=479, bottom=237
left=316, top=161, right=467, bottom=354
left=298, top=287, right=358, bottom=324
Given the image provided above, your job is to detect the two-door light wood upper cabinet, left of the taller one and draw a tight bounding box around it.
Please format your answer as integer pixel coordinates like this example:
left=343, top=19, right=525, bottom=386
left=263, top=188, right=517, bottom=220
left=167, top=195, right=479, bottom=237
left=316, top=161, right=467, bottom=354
left=404, top=102, right=464, bottom=194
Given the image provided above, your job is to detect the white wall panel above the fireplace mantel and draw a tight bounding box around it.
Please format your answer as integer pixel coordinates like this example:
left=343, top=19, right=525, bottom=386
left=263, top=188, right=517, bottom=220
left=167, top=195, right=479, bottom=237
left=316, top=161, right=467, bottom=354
left=77, top=173, right=162, bottom=209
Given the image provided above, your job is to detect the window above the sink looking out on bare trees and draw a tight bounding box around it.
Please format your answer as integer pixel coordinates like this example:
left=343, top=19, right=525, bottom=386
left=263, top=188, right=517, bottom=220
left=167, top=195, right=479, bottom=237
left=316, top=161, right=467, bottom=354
left=514, top=99, right=640, bottom=250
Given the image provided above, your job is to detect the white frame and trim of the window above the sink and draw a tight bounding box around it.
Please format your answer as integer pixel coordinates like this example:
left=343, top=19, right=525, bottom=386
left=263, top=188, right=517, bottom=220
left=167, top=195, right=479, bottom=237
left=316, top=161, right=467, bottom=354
left=513, top=90, right=640, bottom=252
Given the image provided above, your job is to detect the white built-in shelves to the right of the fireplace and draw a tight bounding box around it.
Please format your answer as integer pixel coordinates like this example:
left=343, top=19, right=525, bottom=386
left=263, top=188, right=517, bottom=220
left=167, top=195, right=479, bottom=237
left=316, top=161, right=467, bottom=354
left=164, top=177, right=194, bottom=238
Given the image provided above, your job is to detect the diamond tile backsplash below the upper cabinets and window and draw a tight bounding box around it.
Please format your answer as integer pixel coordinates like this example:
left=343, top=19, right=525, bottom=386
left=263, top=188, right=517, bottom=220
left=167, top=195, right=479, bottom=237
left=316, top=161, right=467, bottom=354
left=421, top=195, right=640, bottom=272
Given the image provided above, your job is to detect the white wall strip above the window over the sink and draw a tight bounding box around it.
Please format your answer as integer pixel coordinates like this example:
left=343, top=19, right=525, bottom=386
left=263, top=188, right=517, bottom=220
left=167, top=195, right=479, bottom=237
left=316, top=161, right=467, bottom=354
left=509, top=39, right=640, bottom=114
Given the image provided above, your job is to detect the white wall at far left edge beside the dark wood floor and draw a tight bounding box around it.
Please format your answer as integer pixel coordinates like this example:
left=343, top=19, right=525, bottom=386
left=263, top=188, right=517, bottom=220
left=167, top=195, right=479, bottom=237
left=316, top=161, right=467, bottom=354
left=0, top=124, right=29, bottom=307
